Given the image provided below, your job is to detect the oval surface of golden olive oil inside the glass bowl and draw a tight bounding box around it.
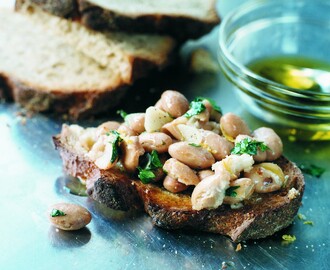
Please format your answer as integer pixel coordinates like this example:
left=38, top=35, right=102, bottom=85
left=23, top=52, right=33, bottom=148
left=247, top=56, right=330, bottom=93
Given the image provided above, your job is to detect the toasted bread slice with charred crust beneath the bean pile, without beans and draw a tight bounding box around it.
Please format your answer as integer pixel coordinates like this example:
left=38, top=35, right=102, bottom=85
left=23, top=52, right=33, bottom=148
left=53, top=132, right=304, bottom=242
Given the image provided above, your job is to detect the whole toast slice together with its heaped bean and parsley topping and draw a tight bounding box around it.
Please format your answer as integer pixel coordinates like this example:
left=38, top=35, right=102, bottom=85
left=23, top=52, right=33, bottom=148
left=53, top=91, right=305, bottom=242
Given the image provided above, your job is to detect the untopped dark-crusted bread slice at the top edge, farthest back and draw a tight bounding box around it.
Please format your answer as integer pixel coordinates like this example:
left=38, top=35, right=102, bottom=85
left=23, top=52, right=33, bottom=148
left=16, top=0, right=220, bottom=41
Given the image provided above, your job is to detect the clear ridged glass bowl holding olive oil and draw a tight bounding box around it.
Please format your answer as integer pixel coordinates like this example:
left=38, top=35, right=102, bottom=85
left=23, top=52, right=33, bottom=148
left=219, top=0, right=330, bottom=140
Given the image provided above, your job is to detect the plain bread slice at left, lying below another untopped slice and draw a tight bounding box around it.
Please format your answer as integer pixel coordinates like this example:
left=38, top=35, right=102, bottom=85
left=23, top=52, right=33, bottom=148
left=0, top=8, right=176, bottom=118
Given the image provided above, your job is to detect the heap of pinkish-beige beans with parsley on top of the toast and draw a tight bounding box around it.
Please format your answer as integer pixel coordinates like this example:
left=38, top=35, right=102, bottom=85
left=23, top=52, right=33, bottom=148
left=62, top=90, right=286, bottom=210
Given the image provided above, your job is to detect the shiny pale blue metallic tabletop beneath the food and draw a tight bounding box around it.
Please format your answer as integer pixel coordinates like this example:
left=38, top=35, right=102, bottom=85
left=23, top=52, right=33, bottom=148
left=0, top=1, right=330, bottom=269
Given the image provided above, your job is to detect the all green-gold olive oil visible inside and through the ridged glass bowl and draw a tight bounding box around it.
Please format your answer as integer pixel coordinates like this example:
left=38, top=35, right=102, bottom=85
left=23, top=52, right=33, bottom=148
left=247, top=55, right=330, bottom=141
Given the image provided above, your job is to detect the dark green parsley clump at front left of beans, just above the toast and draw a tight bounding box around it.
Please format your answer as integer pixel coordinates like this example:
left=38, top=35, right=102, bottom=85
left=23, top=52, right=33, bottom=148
left=138, top=150, right=163, bottom=184
